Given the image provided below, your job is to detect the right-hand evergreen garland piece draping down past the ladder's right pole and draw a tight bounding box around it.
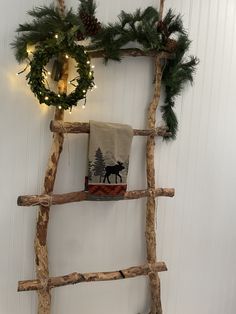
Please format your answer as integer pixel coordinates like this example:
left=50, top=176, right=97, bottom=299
left=89, top=7, right=198, bottom=139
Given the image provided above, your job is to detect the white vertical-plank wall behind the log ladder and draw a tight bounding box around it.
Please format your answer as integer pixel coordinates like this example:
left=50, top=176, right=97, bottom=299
left=0, top=0, right=236, bottom=314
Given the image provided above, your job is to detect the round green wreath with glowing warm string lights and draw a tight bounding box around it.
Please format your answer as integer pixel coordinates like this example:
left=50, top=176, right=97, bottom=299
left=27, top=39, right=94, bottom=109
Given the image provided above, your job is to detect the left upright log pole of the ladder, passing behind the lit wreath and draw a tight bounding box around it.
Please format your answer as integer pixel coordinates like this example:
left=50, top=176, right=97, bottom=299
left=34, top=0, right=68, bottom=314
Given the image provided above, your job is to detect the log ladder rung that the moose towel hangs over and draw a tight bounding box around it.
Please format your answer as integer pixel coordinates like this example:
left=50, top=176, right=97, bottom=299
left=50, top=121, right=171, bottom=137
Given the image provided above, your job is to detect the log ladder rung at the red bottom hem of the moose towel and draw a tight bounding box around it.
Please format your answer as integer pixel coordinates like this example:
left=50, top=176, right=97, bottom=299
left=17, top=188, right=175, bottom=207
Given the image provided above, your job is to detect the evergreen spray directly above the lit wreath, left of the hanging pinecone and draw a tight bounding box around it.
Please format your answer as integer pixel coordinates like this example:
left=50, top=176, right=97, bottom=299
left=11, top=0, right=99, bottom=63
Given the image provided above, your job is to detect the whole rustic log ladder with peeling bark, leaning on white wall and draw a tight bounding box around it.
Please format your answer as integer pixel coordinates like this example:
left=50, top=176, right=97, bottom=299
left=17, top=0, right=174, bottom=314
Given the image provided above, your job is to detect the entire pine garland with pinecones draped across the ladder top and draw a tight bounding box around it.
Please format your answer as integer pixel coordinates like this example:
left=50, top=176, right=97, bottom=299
left=12, top=0, right=198, bottom=138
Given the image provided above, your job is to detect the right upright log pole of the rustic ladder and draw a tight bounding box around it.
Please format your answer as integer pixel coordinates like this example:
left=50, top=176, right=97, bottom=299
left=146, top=0, right=164, bottom=314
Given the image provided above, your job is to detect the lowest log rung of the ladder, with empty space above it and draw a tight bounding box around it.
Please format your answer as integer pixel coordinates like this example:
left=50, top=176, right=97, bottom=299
left=18, top=262, right=167, bottom=291
